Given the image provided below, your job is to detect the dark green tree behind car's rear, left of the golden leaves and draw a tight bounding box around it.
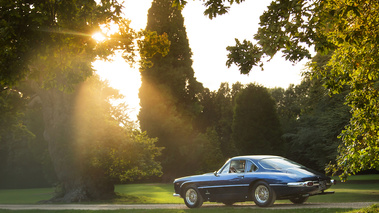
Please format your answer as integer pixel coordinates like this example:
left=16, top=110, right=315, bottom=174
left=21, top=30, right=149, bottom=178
left=270, top=52, right=351, bottom=171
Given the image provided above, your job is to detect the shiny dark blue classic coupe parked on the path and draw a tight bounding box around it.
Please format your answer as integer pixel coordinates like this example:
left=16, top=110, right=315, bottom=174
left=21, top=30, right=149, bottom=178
left=174, top=155, right=335, bottom=208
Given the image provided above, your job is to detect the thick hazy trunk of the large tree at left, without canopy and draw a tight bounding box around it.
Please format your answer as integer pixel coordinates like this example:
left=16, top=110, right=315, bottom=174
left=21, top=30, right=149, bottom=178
left=34, top=87, right=114, bottom=203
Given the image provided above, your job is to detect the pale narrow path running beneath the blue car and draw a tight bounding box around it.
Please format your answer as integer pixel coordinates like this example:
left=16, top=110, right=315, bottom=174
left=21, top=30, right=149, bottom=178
left=0, top=202, right=374, bottom=210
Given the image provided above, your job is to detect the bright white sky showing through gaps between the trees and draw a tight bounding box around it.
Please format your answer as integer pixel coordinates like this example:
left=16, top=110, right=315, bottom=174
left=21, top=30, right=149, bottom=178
left=94, top=0, right=305, bottom=120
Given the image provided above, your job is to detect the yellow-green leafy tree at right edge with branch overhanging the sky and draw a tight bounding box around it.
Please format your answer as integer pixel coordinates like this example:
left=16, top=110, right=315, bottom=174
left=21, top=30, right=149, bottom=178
left=183, top=0, right=379, bottom=178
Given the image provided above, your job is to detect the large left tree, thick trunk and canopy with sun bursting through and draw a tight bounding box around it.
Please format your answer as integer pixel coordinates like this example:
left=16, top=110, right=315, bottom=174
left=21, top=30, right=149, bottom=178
left=0, top=0, right=166, bottom=202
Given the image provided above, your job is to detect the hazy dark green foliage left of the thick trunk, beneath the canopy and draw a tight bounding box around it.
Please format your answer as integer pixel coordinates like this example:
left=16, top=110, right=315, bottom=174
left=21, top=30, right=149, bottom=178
left=0, top=85, right=56, bottom=188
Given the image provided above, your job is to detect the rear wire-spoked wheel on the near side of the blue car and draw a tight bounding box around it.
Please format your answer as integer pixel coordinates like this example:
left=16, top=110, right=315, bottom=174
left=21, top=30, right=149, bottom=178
left=253, top=181, right=276, bottom=207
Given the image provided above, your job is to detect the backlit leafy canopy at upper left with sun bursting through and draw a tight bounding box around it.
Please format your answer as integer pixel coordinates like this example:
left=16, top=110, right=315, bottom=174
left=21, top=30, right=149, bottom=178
left=0, top=0, right=134, bottom=91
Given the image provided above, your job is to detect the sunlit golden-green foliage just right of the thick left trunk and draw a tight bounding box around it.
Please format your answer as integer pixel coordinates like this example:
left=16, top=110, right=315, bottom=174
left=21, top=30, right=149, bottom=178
left=72, top=76, right=162, bottom=183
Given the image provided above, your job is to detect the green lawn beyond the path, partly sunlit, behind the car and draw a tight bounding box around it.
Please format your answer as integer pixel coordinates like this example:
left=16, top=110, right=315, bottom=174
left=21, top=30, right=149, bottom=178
left=0, top=175, right=379, bottom=204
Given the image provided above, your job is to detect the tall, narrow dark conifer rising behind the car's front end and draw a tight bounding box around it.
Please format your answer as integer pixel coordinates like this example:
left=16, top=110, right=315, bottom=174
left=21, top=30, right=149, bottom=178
left=138, top=0, right=202, bottom=178
